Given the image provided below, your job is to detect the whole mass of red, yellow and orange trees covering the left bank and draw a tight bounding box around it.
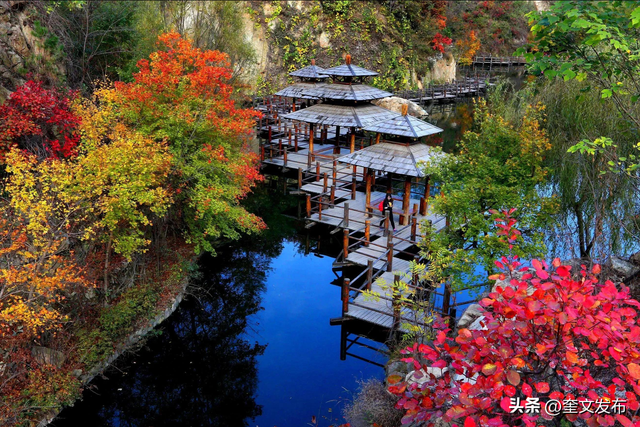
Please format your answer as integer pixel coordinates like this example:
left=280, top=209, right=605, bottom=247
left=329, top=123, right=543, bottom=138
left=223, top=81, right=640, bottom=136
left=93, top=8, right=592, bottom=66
left=0, top=33, right=264, bottom=425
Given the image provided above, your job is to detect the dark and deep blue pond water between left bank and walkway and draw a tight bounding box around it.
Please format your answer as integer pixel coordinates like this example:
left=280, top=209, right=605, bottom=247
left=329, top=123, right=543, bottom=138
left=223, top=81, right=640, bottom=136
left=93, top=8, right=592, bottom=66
left=53, top=189, right=385, bottom=427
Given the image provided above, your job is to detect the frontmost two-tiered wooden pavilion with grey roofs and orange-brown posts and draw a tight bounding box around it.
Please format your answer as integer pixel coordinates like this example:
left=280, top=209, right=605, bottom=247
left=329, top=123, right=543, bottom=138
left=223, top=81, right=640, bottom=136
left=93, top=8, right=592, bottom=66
left=338, top=105, right=443, bottom=225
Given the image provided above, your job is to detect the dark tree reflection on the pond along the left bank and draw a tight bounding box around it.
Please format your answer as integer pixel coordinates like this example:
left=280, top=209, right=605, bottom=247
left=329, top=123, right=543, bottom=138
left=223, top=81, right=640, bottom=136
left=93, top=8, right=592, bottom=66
left=54, top=247, right=271, bottom=427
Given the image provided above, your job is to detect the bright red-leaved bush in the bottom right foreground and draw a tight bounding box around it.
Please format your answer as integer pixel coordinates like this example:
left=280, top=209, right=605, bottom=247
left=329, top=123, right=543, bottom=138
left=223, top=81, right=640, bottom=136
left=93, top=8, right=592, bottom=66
left=389, top=217, right=640, bottom=427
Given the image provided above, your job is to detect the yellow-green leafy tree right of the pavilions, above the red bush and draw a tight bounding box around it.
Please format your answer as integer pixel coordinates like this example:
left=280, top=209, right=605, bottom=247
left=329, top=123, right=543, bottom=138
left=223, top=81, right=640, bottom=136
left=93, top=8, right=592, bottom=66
left=423, top=101, right=557, bottom=290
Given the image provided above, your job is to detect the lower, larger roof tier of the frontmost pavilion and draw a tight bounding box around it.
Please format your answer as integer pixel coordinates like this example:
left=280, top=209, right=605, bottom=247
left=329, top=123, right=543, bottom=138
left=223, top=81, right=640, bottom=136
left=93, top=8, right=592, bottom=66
left=338, top=142, right=445, bottom=177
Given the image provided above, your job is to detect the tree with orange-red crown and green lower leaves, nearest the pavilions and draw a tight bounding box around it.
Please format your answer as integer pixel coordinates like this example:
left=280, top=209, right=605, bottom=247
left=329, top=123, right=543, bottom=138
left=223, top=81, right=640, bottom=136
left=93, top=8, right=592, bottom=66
left=98, top=33, right=264, bottom=251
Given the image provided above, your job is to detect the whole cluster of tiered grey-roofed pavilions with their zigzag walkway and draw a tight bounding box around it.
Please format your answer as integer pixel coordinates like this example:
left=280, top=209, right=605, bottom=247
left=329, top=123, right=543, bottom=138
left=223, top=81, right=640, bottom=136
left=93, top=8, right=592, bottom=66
left=260, top=56, right=470, bottom=329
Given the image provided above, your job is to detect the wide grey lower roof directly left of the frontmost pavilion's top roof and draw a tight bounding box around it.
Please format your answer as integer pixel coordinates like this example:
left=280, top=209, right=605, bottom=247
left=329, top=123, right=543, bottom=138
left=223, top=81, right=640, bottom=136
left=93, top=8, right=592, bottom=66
left=284, top=103, right=398, bottom=128
